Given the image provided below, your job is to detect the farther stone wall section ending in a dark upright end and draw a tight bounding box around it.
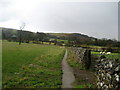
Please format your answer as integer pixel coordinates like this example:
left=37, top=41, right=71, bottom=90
left=71, top=47, right=91, bottom=69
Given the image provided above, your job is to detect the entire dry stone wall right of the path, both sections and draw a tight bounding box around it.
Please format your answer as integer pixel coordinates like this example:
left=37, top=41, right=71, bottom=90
left=71, top=47, right=120, bottom=90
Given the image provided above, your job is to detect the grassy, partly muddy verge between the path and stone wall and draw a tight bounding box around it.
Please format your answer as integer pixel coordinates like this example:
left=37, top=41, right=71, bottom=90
left=67, top=49, right=95, bottom=88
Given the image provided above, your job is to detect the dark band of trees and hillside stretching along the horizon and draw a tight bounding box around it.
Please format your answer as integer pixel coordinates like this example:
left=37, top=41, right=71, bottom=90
left=2, top=28, right=120, bottom=47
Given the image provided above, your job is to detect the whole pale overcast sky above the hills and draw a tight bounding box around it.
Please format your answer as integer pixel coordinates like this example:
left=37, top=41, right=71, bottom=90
left=0, top=0, right=118, bottom=39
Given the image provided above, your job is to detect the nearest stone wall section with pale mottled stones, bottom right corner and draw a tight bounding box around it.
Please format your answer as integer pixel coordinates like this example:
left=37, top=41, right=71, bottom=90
left=96, top=59, right=120, bottom=90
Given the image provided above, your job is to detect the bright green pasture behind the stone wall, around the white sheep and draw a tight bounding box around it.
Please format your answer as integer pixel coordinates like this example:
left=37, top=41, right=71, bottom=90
left=91, top=51, right=120, bottom=59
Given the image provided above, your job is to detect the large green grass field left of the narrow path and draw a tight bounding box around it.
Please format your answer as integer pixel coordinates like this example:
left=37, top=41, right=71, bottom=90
left=2, top=41, right=65, bottom=88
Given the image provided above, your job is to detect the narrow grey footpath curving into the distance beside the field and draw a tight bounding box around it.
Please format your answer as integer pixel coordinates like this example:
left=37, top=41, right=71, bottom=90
left=62, top=49, right=75, bottom=88
